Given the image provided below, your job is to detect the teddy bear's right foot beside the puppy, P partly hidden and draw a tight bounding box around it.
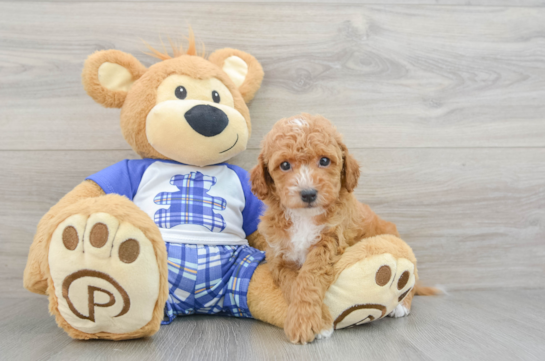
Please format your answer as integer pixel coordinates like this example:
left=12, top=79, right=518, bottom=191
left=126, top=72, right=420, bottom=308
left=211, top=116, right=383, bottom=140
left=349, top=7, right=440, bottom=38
left=324, top=235, right=418, bottom=330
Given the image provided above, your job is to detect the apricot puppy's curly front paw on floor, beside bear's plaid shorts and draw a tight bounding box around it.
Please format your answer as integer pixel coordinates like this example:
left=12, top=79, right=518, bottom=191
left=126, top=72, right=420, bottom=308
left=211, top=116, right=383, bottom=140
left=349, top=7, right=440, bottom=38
left=284, top=303, right=322, bottom=345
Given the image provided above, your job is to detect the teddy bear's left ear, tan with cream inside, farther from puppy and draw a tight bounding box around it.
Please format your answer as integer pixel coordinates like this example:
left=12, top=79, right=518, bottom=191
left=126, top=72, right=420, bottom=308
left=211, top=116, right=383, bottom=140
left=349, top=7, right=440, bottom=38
left=81, top=50, right=146, bottom=108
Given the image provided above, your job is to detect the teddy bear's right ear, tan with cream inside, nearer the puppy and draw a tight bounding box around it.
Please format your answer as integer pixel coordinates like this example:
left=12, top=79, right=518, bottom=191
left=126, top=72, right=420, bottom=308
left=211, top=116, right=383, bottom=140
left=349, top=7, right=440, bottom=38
left=208, top=49, right=263, bottom=103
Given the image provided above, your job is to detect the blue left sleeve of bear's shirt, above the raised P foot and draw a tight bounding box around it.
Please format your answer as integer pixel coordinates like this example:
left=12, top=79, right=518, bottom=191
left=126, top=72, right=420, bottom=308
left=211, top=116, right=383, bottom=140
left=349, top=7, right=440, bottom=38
left=86, top=159, right=156, bottom=201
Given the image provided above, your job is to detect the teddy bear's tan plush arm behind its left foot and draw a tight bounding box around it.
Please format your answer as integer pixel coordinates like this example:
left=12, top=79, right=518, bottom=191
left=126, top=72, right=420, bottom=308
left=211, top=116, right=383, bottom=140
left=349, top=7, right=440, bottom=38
left=23, top=180, right=104, bottom=294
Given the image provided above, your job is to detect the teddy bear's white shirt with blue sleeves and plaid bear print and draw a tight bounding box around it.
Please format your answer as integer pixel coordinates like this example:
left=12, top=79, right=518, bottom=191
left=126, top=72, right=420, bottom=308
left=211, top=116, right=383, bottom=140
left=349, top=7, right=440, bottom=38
left=87, top=159, right=263, bottom=245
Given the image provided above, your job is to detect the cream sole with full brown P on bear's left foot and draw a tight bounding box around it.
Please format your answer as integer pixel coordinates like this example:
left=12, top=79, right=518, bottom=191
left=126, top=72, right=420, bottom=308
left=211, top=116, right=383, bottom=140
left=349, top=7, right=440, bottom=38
left=49, top=213, right=159, bottom=333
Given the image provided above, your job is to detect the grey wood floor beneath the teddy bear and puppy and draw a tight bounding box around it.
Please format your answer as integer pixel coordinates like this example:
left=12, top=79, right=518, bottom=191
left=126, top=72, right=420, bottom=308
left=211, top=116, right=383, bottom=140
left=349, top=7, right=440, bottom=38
left=0, top=290, right=545, bottom=361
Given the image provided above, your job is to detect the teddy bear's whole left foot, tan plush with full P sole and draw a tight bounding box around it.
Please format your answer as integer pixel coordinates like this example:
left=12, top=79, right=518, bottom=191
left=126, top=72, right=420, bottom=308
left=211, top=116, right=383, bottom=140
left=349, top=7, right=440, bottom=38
left=48, top=195, right=168, bottom=340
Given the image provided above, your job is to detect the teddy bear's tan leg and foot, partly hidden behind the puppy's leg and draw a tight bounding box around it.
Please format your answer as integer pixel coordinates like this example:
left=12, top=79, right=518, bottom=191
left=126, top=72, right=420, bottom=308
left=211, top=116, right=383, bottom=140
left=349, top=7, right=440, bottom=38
left=248, top=235, right=417, bottom=338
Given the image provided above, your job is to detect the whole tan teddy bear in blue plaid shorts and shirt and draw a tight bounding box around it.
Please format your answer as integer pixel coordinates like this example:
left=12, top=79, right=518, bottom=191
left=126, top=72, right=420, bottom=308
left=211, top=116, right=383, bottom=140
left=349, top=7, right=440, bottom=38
left=24, top=35, right=417, bottom=341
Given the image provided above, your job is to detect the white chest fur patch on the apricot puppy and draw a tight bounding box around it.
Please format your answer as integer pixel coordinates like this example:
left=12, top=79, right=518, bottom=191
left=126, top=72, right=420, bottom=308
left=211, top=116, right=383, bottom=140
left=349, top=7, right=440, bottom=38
left=284, top=208, right=324, bottom=266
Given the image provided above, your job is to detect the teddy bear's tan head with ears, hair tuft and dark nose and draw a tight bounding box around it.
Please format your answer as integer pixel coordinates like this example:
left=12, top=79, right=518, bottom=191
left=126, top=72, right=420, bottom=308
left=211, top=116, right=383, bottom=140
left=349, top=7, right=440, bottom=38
left=82, top=39, right=263, bottom=166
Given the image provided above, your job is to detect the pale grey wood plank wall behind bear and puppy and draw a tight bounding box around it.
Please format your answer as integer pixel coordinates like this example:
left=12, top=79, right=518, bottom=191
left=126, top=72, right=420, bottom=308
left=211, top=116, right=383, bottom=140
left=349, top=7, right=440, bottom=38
left=0, top=0, right=545, bottom=297
